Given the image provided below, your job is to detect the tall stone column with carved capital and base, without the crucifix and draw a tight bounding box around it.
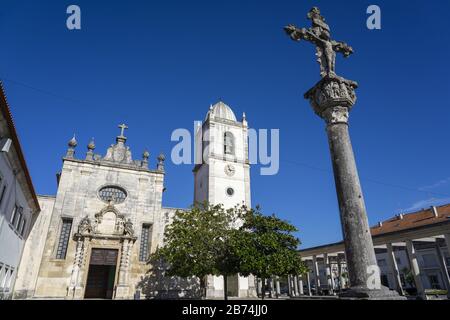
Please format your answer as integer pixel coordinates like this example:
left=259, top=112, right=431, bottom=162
left=305, top=76, right=400, bottom=299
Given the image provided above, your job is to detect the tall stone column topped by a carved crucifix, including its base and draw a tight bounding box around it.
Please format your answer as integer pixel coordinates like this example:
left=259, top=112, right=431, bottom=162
left=285, top=7, right=400, bottom=299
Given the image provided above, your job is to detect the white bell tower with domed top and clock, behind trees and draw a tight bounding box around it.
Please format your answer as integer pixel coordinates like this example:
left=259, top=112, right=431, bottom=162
left=194, top=101, right=256, bottom=298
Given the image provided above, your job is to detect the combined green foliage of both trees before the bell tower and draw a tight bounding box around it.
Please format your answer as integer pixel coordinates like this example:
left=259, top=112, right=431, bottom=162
left=152, top=203, right=306, bottom=299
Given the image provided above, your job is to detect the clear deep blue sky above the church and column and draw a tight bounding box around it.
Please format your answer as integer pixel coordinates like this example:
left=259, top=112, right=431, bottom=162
left=0, top=0, right=450, bottom=247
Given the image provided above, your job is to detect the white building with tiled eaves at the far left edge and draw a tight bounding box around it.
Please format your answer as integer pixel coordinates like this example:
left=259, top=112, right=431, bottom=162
left=0, top=83, right=40, bottom=299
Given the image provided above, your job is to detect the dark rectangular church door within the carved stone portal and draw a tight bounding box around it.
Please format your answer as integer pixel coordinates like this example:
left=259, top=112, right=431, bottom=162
left=84, top=249, right=118, bottom=299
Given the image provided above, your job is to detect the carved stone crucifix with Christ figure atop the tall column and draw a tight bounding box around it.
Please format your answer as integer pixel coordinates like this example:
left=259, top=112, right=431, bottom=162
left=284, top=7, right=353, bottom=78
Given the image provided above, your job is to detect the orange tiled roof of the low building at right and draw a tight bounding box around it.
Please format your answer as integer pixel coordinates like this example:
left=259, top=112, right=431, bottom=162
left=371, top=204, right=450, bottom=236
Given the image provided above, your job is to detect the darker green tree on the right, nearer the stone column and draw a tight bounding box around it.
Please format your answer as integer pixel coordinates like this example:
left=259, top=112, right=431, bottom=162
left=230, top=207, right=307, bottom=299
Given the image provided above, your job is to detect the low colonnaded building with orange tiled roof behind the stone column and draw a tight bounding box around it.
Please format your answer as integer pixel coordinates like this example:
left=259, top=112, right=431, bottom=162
left=300, top=204, right=450, bottom=297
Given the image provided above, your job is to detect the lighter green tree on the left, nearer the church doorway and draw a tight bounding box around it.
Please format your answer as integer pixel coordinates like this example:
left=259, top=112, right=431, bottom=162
left=151, top=203, right=239, bottom=300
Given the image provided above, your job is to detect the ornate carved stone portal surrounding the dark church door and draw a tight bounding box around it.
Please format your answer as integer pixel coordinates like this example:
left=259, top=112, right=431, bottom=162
left=67, top=205, right=137, bottom=299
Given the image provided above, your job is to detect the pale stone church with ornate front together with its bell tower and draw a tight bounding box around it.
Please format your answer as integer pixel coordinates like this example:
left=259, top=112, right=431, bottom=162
left=14, top=102, right=256, bottom=299
